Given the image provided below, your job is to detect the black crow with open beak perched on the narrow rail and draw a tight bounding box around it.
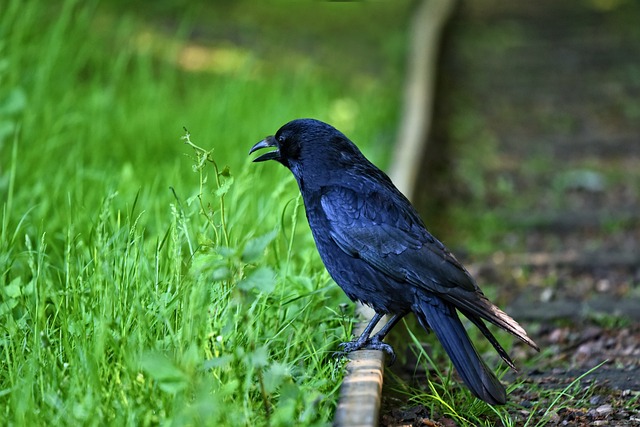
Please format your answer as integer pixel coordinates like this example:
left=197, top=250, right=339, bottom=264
left=249, top=119, right=539, bottom=405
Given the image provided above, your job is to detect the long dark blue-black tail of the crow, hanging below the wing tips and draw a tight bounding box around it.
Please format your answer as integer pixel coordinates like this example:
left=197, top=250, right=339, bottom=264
left=414, top=297, right=507, bottom=405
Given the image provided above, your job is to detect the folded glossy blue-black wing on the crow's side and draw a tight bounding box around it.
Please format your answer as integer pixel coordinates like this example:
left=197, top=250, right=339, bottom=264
left=320, top=186, right=477, bottom=298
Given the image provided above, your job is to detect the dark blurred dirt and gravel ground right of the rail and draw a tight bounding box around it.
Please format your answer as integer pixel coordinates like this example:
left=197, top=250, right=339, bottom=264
left=382, top=0, right=640, bottom=426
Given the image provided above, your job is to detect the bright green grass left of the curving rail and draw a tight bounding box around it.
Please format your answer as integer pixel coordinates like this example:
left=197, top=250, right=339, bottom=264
left=0, top=0, right=403, bottom=425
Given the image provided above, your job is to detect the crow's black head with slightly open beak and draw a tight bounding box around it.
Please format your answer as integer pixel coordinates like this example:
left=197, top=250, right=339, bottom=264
left=249, top=119, right=362, bottom=178
